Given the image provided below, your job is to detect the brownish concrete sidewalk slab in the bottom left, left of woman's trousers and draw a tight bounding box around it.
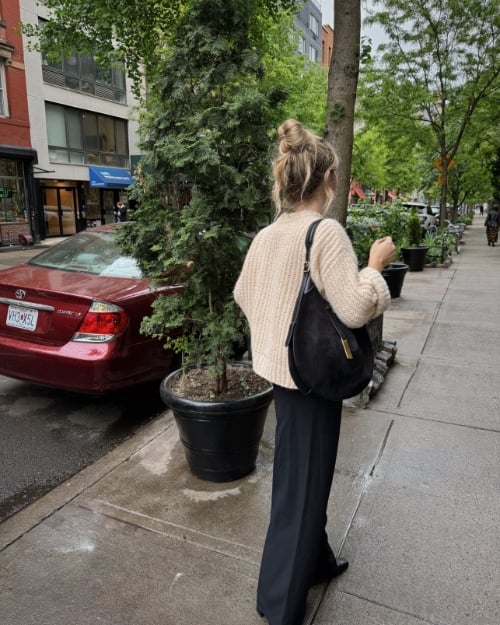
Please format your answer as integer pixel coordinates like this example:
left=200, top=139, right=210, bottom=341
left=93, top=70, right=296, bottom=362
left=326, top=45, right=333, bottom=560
left=1, top=505, right=261, bottom=625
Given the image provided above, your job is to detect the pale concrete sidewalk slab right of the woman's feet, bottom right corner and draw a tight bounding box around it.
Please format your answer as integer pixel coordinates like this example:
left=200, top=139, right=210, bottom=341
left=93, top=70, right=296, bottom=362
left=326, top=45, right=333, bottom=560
left=317, top=418, right=500, bottom=625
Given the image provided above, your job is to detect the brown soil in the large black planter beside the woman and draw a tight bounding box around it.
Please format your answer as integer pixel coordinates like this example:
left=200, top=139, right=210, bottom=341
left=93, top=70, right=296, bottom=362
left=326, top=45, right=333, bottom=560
left=170, top=365, right=270, bottom=401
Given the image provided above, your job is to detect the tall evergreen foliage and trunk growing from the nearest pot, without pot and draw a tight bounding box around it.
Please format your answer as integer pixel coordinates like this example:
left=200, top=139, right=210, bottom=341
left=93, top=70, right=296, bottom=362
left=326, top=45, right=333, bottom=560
left=116, top=0, right=284, bottom=395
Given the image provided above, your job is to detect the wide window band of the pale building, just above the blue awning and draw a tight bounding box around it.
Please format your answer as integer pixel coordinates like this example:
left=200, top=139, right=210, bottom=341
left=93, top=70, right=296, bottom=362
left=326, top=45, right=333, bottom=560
left=45, top=102, right=129, bottom=167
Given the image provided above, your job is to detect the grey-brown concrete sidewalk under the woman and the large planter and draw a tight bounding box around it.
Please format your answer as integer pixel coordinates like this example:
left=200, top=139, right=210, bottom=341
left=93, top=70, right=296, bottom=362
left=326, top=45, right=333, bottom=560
left=0, top=216, right=500, bottom=625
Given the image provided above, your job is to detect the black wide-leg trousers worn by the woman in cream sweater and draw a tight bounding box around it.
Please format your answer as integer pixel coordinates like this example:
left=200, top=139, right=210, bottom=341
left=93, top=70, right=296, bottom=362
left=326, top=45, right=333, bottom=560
left=257, top=386, right=342, bottom=625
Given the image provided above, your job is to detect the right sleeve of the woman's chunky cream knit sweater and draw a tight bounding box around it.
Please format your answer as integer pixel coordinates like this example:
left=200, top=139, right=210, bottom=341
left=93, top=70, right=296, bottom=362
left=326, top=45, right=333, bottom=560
left=311, top=219, right=390, bottom=328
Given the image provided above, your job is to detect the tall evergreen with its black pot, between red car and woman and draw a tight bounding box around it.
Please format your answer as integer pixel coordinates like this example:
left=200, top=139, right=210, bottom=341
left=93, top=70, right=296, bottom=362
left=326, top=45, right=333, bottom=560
left=117, top=0, right=290, bottom=481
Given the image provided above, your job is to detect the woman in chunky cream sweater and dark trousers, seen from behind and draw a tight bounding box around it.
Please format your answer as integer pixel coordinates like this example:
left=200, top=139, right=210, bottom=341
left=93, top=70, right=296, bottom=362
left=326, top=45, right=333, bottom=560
left=234, top=120, right=394, bottom=625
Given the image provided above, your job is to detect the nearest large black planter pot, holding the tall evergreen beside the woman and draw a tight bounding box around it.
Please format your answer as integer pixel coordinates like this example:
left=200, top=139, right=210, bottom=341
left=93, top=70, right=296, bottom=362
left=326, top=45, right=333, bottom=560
left=160, top=365, right=273, bottom=482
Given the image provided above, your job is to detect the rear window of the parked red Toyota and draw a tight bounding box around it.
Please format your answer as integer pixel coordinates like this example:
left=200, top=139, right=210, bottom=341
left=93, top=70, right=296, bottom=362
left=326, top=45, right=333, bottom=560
left=28, top=231, right=142, bottom=278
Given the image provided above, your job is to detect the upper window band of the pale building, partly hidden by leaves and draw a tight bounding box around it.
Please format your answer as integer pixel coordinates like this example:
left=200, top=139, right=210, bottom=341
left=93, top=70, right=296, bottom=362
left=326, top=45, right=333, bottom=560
left=41, top=20, right=127, bottom=104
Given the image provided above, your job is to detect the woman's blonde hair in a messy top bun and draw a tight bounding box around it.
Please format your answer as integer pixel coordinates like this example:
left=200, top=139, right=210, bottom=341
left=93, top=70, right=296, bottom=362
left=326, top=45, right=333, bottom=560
left=273, top=119, right=338, bottom=213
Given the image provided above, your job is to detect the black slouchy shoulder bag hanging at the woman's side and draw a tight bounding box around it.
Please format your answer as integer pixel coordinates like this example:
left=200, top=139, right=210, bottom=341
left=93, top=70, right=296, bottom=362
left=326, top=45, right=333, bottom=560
left=286, top=219, right=374, bottom=401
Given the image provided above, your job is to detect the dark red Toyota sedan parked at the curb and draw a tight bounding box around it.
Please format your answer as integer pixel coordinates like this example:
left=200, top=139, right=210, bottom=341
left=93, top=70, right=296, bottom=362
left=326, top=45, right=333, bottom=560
left=0, top=226, right=181, bottom=393
